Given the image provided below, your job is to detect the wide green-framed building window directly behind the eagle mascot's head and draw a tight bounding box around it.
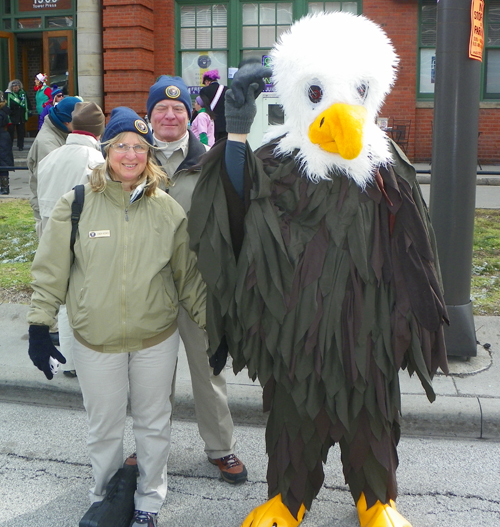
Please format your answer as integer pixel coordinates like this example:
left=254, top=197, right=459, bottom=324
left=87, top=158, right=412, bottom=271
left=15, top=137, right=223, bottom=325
left=178, top=0, right=363, bottom=83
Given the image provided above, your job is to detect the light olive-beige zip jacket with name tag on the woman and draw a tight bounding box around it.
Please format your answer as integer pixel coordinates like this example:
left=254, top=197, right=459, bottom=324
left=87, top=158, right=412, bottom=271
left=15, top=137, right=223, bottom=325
left=28, top=181, right=206, bottom=353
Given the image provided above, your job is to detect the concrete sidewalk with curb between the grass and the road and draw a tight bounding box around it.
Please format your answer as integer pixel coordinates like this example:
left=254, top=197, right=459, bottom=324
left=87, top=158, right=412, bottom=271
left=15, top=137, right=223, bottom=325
left=0, top=304, right=500, bottom=440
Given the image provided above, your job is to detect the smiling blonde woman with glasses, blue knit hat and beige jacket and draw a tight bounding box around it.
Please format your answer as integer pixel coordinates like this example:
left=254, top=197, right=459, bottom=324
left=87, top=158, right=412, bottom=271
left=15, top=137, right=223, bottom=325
left=27, top=107, right=206, bottom=527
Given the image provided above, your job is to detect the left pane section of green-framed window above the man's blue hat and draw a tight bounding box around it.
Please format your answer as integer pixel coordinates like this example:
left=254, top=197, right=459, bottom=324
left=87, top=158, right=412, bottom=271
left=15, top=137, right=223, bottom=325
left=180, top=4, right=227, bottom=94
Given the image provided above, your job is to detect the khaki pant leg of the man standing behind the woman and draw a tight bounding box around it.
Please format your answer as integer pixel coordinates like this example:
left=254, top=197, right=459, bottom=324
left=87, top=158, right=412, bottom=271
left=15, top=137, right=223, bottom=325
left=177, top=307, right=235, bottom=459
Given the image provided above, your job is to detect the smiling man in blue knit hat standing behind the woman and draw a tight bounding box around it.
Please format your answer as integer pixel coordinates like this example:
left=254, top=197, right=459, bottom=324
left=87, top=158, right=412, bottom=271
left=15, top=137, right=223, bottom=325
left=146, top=75, right=248, bottom=485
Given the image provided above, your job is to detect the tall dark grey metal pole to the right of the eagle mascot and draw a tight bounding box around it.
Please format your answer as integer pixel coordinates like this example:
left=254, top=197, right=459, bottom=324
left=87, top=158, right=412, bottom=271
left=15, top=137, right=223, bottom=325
left=429, top=0, right=481, bottom=357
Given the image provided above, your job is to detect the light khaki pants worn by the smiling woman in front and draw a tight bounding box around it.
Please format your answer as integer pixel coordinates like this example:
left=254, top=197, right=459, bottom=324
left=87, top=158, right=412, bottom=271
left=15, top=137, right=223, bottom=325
left=73, top=331, right=179, bottom=512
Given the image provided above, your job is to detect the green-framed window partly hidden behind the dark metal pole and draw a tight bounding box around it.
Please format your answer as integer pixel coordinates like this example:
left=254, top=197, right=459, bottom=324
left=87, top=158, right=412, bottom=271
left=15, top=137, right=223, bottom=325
left=418, top=0, right=500, bottom=100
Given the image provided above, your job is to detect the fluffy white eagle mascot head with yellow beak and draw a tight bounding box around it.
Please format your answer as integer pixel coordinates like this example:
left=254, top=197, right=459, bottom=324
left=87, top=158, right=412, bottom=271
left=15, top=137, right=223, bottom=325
left=265, top=12, right=398, bottom=188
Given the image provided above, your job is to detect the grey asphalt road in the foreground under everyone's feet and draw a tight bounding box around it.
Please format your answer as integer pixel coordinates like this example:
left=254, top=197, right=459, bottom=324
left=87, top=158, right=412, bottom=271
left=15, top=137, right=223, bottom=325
left=0, top=403, right=500, bottom=527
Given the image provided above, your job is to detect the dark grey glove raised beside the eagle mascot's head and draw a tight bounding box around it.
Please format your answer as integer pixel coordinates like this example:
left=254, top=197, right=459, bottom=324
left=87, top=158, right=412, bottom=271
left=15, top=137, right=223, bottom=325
left=225, top=62, right=271, bottom=134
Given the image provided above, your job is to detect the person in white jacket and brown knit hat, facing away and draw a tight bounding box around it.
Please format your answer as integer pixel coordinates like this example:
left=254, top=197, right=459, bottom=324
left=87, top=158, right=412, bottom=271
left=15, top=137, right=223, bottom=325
left=37, top=102, right=105, bottom=377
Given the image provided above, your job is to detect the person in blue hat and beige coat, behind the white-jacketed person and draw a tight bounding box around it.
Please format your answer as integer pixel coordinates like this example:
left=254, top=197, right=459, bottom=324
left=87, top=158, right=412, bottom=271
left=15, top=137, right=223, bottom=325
left=27, top=97, right=82, bottom=237
